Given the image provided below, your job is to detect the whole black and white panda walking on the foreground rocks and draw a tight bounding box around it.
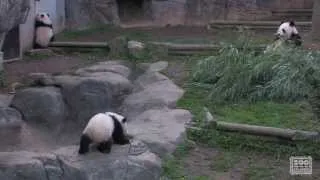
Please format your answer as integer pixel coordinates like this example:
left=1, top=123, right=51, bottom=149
left=78, top=112, right=130, bottom=154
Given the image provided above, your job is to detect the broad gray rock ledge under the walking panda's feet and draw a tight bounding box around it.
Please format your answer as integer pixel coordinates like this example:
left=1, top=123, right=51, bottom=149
left=0, top=143, right=161, bottom=180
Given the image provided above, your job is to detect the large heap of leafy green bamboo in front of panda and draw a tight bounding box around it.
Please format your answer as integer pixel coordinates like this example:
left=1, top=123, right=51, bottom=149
left=193, top=33, right=320, bottom=107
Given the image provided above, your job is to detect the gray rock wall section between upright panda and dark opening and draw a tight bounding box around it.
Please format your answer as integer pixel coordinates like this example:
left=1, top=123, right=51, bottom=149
left=65, top=0, right=120, bottom=29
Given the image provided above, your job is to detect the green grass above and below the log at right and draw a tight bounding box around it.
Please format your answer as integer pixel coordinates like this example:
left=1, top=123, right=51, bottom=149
left=178, top=83, right=320, bottom=158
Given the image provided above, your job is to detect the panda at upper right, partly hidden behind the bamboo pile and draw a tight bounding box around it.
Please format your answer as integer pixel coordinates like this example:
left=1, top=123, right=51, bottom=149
left=276, top=21, right=302, bottom=46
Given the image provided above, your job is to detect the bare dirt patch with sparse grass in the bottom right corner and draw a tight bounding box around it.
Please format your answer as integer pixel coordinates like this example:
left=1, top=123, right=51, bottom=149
left=182, top=145, right=320, bottom=180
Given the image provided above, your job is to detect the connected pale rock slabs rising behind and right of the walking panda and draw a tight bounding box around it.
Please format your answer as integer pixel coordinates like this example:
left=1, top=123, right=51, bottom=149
left=121, top=62, right=192, bottom=157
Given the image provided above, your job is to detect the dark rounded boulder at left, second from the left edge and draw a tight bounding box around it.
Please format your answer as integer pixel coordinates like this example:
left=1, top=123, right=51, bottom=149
left=10, top=87, right=67, bottom=125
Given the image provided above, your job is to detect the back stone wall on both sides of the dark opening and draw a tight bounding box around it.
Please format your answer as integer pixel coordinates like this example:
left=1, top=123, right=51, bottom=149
left=66, top=0, right=313, bottom=27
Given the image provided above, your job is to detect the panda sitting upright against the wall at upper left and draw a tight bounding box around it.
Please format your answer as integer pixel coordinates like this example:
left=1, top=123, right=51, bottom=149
left=34, top=13, right=54, bottom=49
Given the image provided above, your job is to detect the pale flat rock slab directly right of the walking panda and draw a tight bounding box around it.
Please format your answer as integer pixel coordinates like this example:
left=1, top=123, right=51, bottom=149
left=128, top=108, right=192, bottom=157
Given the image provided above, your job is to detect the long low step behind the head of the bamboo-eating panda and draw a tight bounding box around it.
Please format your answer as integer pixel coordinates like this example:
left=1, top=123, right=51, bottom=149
left=209, top=21, right=312, bottom=31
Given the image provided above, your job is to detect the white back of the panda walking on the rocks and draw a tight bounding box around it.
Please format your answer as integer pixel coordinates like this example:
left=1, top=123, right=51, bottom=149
left=83, top=113, right=114, bottom=143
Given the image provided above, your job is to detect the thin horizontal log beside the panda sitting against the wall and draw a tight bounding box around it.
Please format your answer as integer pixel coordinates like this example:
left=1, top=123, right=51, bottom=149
left=49, top=41, right=109, bottom=48
